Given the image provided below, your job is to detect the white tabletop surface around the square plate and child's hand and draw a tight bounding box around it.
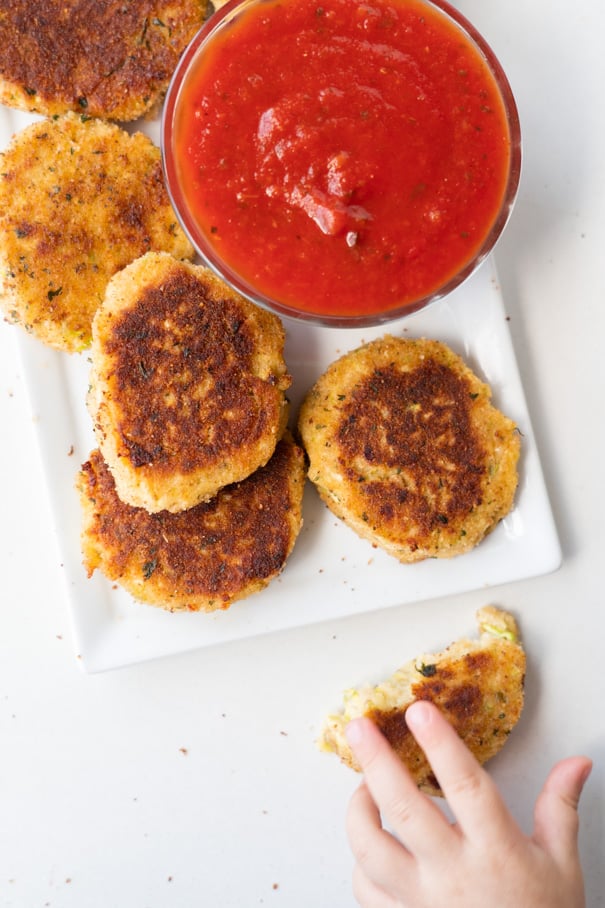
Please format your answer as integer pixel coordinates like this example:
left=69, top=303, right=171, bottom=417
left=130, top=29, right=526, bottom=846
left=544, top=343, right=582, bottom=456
left=0, top=0, right=605, bottom=908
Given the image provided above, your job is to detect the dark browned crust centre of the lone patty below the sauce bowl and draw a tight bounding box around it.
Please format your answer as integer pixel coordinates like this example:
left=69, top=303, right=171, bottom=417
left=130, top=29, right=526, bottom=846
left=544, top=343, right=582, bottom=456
left=337, top=359, right=485, bottom=536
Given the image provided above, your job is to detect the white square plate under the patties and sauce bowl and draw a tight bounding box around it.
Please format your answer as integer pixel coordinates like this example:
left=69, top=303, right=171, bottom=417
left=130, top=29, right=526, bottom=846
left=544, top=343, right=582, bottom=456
left=0, top=109, right=561, bottom=672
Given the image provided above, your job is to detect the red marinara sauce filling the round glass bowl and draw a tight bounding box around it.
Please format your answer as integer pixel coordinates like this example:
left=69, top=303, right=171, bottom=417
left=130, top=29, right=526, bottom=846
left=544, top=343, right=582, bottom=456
left=169, top=0, right=514, bottom=321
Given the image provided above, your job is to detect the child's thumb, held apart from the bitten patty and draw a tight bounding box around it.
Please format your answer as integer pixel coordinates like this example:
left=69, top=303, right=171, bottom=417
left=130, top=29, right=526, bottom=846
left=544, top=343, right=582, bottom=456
left=534, top=757, right=592, bottom=863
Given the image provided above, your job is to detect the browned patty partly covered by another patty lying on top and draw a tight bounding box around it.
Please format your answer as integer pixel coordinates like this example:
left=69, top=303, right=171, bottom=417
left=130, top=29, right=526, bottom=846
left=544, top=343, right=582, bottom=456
left=78, top=437, right=305, bottom=612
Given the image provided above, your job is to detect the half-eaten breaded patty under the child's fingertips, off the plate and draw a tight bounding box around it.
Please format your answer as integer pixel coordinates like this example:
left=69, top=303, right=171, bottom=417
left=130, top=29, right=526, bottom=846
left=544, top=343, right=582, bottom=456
left=319, top=606, right=525, bottom=795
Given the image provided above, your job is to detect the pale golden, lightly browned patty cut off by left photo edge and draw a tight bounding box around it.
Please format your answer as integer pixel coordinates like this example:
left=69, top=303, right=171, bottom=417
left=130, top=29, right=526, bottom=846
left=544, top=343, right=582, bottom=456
left=0, top=114, right=194, bottom=352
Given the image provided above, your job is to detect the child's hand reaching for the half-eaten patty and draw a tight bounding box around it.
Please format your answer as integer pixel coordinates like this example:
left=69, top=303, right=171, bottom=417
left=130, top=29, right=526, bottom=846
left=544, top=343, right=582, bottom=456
left=347, top=701, right=592, bottom=908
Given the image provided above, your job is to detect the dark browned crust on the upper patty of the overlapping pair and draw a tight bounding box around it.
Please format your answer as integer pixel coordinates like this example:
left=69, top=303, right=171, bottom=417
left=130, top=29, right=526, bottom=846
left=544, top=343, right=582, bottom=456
left=104, top=269, right=282, bottom=473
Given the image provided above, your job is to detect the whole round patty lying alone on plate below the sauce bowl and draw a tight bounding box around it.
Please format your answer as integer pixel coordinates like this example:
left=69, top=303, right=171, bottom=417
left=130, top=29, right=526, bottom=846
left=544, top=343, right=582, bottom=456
left=298, top=336, right=519, bottom=562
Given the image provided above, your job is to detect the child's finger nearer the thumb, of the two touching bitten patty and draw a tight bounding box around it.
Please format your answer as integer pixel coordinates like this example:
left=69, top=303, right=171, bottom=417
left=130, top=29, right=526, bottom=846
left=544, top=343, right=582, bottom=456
left=405, top=701, right=514, bottom=840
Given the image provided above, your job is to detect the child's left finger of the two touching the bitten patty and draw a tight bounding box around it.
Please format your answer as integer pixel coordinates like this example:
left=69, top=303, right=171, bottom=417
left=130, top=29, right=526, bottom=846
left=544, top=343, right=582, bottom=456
left=347, top=718, right=453, bottom=856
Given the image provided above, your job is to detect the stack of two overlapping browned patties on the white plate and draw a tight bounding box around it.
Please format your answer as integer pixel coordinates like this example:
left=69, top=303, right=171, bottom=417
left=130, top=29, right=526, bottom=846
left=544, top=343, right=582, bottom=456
left=78, top=253, right=305, bottom=611
